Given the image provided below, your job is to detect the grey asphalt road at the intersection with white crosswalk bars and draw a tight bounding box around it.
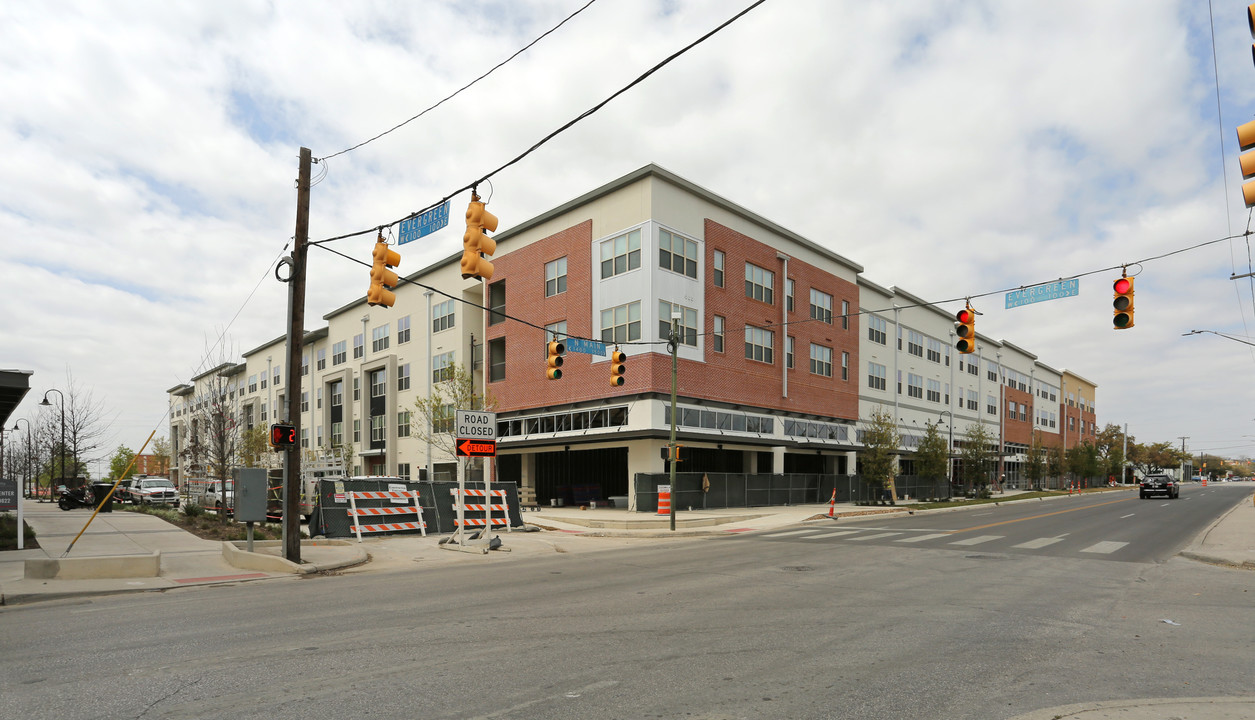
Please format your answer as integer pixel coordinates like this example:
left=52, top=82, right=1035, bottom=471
left=0, top=487, right=1255, bottom=720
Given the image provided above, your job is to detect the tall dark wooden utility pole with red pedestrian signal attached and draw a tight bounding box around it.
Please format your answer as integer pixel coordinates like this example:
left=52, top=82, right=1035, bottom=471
left=284, top=148, right=311, bottom=563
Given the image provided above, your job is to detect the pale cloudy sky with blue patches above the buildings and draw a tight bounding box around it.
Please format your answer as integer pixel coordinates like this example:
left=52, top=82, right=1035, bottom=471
left=0, top=0, right=1255, bottom=469
